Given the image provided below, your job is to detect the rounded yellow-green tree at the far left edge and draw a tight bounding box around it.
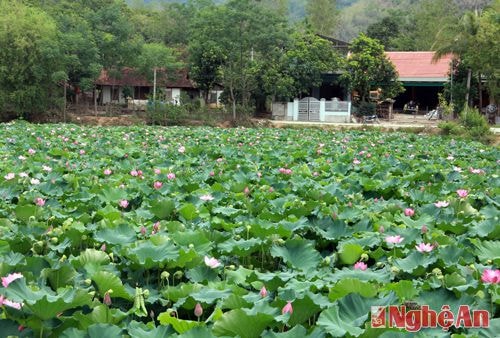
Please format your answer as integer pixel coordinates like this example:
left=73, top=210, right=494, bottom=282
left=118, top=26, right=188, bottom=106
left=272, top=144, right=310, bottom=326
left=0, top=1, right=66, bottom=116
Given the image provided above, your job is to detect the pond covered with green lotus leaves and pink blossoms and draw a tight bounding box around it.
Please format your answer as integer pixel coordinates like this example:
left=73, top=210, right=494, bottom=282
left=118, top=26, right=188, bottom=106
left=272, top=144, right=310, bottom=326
left=0, top=122, right=500, bottom=337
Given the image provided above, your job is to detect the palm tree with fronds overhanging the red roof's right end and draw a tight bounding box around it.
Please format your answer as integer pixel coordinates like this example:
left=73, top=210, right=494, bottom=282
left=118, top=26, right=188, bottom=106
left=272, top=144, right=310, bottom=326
left=432, top=11, right=481, bottom=105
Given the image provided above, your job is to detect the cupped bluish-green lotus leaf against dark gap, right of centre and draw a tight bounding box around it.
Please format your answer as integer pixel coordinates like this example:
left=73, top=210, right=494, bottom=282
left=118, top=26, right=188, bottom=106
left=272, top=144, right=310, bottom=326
left=270, top=239, right=321, bottom=273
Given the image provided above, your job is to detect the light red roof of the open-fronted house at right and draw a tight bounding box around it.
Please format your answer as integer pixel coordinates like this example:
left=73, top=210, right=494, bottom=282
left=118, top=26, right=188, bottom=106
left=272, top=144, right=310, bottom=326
left=386, top=51, right=452, bottom=82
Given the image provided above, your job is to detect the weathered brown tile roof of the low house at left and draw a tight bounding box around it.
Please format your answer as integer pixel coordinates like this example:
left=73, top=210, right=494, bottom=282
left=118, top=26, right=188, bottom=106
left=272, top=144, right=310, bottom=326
left=95, top=68, right=196, bottom=88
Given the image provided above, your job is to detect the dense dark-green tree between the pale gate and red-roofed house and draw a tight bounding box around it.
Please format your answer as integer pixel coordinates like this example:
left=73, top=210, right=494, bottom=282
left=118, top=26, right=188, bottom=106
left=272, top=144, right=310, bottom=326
left=342, top=33, right=403, bottom=102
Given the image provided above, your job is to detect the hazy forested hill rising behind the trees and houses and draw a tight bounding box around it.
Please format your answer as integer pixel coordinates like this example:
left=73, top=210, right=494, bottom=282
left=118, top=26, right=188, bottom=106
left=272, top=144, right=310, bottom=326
left=127, top=0, right=491, bottom=41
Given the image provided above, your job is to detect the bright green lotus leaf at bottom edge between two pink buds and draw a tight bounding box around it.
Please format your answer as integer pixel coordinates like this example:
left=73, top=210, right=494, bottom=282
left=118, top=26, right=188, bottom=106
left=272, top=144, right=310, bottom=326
left=212, top=309, right=274, bottom=338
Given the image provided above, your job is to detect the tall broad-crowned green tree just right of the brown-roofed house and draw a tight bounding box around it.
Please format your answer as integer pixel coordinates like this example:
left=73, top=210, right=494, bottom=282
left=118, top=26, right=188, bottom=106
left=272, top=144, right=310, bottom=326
left=190, top=0, right=286, bottom=119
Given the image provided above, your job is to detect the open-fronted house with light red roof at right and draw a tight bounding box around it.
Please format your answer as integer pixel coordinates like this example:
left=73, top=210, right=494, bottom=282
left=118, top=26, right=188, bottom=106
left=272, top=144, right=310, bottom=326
left=386, top=51, right=452, bottom=113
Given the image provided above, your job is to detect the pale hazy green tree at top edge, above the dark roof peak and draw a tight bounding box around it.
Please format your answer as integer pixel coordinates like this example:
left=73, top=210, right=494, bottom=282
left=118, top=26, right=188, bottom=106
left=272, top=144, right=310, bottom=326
left=306, top=0, right=339, bottom=36
